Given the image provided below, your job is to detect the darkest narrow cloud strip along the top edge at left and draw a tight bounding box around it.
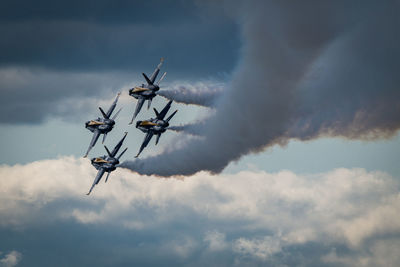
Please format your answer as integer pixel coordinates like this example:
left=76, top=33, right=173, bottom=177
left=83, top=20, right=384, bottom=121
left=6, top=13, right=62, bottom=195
left=0, top=0, right=196, bottom=24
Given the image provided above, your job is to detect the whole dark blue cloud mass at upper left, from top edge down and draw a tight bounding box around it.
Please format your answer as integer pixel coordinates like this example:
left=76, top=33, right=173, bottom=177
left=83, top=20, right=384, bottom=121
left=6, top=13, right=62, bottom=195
left=0, top=1, right=238, bottom=76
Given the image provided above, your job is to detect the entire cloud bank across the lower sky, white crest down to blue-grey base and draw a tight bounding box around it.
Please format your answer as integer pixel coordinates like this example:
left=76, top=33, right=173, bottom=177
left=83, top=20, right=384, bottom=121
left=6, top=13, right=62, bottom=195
left=0, top=157, right=400, bottom=266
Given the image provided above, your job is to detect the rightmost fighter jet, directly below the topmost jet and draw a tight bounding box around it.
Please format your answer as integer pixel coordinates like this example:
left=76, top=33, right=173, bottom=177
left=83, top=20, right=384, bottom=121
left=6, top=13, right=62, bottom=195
left=135, top=100, right=178, bottom=158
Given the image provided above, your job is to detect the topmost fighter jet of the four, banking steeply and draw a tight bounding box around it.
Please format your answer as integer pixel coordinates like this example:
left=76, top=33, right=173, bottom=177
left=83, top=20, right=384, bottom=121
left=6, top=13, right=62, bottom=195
left=129, top=58, right=167, bottom=124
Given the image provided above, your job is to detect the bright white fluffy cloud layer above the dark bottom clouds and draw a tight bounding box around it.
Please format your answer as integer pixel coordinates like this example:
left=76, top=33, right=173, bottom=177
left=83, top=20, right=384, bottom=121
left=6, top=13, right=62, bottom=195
left=0, top=157, right=400, bottom=266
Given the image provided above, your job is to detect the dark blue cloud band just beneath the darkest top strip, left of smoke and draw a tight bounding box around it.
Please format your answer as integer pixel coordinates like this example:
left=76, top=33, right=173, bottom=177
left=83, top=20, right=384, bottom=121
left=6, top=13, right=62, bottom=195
left=0, top=21, right=237, bottom=77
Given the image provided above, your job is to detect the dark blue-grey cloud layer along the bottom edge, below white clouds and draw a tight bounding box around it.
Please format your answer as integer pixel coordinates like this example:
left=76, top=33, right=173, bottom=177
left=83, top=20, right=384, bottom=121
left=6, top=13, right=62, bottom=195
left=0, top=225, right=362, bottom=267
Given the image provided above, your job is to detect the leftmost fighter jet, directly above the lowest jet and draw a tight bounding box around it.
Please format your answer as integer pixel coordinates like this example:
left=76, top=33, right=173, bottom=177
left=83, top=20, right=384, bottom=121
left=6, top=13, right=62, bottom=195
left=83, top=93, right=122, bottom=158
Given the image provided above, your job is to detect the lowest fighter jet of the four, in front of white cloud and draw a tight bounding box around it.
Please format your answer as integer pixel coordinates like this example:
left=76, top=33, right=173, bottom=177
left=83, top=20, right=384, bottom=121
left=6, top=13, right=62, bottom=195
left=87, top=132, right=128, bottom=195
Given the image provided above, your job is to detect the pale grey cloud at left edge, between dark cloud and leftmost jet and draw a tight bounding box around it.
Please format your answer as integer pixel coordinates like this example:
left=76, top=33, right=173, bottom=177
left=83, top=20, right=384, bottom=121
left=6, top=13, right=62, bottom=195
left=0, top=68, right=127, bottom=124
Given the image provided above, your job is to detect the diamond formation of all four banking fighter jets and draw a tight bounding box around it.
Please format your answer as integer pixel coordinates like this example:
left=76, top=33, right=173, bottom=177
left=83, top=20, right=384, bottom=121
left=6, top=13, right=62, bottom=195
left=84, top=58, right=178, bottom=195
